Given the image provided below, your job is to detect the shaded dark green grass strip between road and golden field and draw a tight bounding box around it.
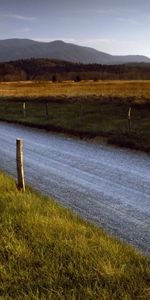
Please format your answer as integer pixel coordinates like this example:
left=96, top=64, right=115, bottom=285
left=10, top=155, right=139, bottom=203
left=0, top=97, right=150, bottom=152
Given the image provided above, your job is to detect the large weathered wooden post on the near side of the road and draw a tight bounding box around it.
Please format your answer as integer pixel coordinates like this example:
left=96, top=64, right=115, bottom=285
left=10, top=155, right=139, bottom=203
left=16, top=139, right=25, bottom=192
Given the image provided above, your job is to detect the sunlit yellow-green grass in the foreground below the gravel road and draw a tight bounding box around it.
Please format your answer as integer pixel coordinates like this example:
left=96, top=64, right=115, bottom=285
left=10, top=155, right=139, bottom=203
left=0, top=173, right=150, bottom=300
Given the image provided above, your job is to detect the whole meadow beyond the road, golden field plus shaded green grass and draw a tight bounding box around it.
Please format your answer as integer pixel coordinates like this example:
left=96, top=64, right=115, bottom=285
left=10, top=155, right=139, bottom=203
left=0, top=80, right=150, bottom=152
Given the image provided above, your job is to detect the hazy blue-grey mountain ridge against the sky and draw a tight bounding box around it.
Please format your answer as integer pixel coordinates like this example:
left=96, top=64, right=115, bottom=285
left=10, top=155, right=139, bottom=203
left=0, top=39, right=150, bottom=65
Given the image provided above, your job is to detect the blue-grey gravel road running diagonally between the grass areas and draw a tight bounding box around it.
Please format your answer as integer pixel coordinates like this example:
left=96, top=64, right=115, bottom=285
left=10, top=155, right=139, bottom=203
left=0, top=122, right=150, bottom=254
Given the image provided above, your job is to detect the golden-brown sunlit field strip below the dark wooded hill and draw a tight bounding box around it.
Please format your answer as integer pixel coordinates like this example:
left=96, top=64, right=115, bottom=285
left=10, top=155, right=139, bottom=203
left=0, top=80, right=150, bottom=101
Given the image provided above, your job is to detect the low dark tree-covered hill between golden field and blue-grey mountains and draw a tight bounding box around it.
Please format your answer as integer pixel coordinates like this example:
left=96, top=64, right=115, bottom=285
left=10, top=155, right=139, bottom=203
left=0, top=58, right=150, bottom=82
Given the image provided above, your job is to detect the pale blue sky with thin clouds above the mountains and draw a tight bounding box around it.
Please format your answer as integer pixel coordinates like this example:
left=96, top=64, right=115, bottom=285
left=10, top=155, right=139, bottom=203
left=0, top=0, right=150, bottom=57
